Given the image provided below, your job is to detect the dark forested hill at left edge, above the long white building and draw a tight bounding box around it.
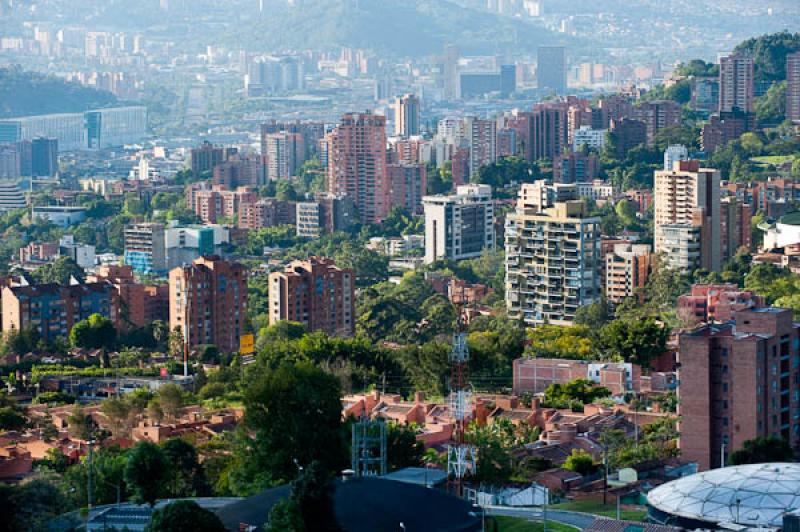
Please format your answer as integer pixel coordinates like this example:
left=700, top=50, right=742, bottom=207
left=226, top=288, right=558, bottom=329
left=0, top=67, right=117, bottom=118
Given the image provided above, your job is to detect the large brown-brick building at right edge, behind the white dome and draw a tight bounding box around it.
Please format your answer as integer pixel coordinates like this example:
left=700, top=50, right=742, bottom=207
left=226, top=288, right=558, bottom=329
left=678, top=308, right=800, bottom=470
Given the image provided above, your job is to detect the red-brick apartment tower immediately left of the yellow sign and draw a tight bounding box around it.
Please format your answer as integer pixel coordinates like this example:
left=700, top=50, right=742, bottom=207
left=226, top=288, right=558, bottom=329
left=169, top=255, right=247, bottom=353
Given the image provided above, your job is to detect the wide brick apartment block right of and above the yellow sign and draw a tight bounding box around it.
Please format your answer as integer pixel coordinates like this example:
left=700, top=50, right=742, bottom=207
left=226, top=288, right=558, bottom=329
left=269, top=257, right=356, bottom=336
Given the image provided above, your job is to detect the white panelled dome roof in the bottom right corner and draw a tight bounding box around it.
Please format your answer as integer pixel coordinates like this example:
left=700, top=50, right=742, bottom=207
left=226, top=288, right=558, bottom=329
left=647, top=463, right=800, bottom=527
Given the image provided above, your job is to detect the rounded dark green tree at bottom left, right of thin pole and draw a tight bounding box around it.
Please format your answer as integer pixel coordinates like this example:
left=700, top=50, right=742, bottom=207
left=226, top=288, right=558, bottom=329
left=124, top=441, right=171, bottom=507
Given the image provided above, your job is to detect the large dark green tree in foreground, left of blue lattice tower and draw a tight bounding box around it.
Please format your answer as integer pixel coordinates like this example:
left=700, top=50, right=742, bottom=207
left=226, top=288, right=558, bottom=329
left=241, top=362, right=347, bottom=490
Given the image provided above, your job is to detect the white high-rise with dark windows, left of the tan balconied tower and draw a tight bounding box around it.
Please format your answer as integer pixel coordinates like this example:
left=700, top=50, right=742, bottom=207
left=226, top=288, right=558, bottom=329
left=422, top=185, right=495, bottom=264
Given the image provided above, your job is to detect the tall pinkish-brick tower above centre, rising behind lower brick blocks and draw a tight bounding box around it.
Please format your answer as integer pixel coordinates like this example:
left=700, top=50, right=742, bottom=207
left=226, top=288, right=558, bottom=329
left=327, top=113, right=391, bottom=224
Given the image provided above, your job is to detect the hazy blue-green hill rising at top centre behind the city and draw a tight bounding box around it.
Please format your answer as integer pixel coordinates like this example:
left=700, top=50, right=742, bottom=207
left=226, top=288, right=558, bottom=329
left=234, top=0, right=568, bottom=56
